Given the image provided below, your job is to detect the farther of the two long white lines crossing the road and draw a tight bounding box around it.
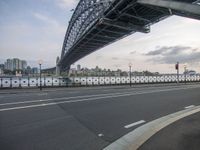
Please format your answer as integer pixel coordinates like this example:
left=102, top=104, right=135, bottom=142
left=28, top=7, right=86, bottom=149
left=0, top=86, right=198, bottom=106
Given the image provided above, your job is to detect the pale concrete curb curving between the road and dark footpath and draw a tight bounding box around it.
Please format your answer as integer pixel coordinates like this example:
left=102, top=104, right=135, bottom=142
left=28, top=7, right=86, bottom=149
left=103, top=106, right=200, bottom=150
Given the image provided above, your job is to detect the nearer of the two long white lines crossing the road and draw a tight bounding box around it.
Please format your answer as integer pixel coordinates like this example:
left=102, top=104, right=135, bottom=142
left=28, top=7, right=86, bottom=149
left=0, top=85, right=200, bottom=112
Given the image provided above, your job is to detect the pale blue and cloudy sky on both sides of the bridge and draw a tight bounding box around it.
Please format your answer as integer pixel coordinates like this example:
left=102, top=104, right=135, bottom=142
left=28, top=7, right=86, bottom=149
left=0, top=0, right=200, bottom=73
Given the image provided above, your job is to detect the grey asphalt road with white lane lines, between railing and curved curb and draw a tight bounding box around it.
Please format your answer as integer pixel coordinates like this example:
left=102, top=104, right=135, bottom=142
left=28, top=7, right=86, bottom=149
left=0, top=84, right=200, bottom=150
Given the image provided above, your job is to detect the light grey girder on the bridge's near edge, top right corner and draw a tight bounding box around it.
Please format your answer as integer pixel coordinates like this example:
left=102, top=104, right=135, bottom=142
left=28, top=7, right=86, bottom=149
left=137, top=0, right=200, bottom=20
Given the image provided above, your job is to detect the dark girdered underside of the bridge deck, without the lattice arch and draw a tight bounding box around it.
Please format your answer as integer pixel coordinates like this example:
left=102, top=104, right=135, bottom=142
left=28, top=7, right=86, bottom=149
left=59, top=0, right=200, bottom=70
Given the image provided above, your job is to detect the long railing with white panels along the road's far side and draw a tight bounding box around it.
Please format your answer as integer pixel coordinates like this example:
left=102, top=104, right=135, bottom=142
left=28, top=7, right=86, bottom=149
left=0, top=75, right=200, bottom=88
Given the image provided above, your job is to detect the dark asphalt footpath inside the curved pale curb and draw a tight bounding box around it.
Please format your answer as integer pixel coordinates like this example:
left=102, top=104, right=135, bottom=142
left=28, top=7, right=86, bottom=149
left=138, top=112, right=200, bottom=150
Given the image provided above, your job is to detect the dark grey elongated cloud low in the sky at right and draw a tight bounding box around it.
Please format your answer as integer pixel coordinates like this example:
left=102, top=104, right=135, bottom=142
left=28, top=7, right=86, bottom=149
left=144, top=46, right=200, bottom=64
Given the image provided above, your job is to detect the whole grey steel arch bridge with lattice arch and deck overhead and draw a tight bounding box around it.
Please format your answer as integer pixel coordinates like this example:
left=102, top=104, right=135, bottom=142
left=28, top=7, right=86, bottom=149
left=57, top=0, right=200, bottom=70
